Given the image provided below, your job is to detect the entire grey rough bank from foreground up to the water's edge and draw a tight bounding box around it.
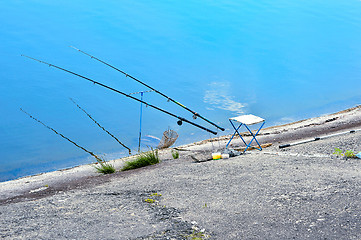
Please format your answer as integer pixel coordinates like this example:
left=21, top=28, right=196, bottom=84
left=0, top=106, right=361, bottom=240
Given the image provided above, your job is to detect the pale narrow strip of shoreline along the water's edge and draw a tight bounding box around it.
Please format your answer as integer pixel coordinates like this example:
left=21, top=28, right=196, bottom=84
left=0, top=105, right=361, bottom=204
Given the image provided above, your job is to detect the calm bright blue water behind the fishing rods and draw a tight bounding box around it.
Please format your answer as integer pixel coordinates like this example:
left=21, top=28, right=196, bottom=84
left=0, top=0, right=361, bottom=181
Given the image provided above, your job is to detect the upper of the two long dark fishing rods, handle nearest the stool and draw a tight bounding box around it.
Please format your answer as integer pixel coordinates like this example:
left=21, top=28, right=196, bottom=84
left=70, top=46, right=225, bottom=131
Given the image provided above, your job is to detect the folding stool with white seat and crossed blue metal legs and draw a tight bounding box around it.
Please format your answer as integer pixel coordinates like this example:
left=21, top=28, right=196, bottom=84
left=226, top=114, right=266, bottom=153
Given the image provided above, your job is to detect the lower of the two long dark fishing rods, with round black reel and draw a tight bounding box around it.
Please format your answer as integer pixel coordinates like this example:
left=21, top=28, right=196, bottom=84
left=21, top=54, right=217, bottom=135
